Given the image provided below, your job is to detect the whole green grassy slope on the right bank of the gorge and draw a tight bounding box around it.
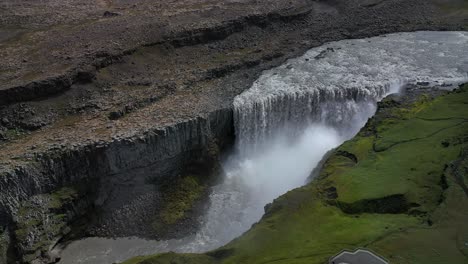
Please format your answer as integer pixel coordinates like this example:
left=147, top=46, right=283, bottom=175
left=125, top=86, right=468, bottom=264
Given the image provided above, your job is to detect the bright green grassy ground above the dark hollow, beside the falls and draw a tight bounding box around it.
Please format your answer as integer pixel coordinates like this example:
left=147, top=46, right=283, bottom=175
left=328, top=88, right=468, bottom=211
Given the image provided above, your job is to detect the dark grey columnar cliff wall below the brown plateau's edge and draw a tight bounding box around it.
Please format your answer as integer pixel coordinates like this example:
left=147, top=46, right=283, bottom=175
left=0, top=109, right=233, bottom=262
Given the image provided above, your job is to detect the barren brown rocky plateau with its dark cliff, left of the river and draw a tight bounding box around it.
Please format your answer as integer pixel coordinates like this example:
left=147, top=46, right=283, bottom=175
left=0, top=0, right=466, bottom=263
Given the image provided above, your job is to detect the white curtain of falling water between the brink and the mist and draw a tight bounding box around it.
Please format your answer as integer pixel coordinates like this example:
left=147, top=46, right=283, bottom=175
left=234, top=83, right=394, bottom=155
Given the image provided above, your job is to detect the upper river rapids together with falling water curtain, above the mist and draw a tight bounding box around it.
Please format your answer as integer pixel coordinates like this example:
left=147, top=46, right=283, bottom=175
left=234, top=32, right=468, bottom=156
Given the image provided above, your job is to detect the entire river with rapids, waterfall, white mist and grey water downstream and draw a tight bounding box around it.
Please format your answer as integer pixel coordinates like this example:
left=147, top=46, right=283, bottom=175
left=61, top=32, right=468, bottom=263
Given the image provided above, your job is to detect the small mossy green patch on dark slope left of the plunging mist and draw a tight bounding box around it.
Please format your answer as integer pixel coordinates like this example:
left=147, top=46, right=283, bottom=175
left=153, top=175, right=207, bottom=233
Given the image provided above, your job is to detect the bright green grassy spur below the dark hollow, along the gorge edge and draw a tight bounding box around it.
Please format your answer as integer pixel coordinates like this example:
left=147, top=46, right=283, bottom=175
left=223, top=191, right=419, bottom=264
